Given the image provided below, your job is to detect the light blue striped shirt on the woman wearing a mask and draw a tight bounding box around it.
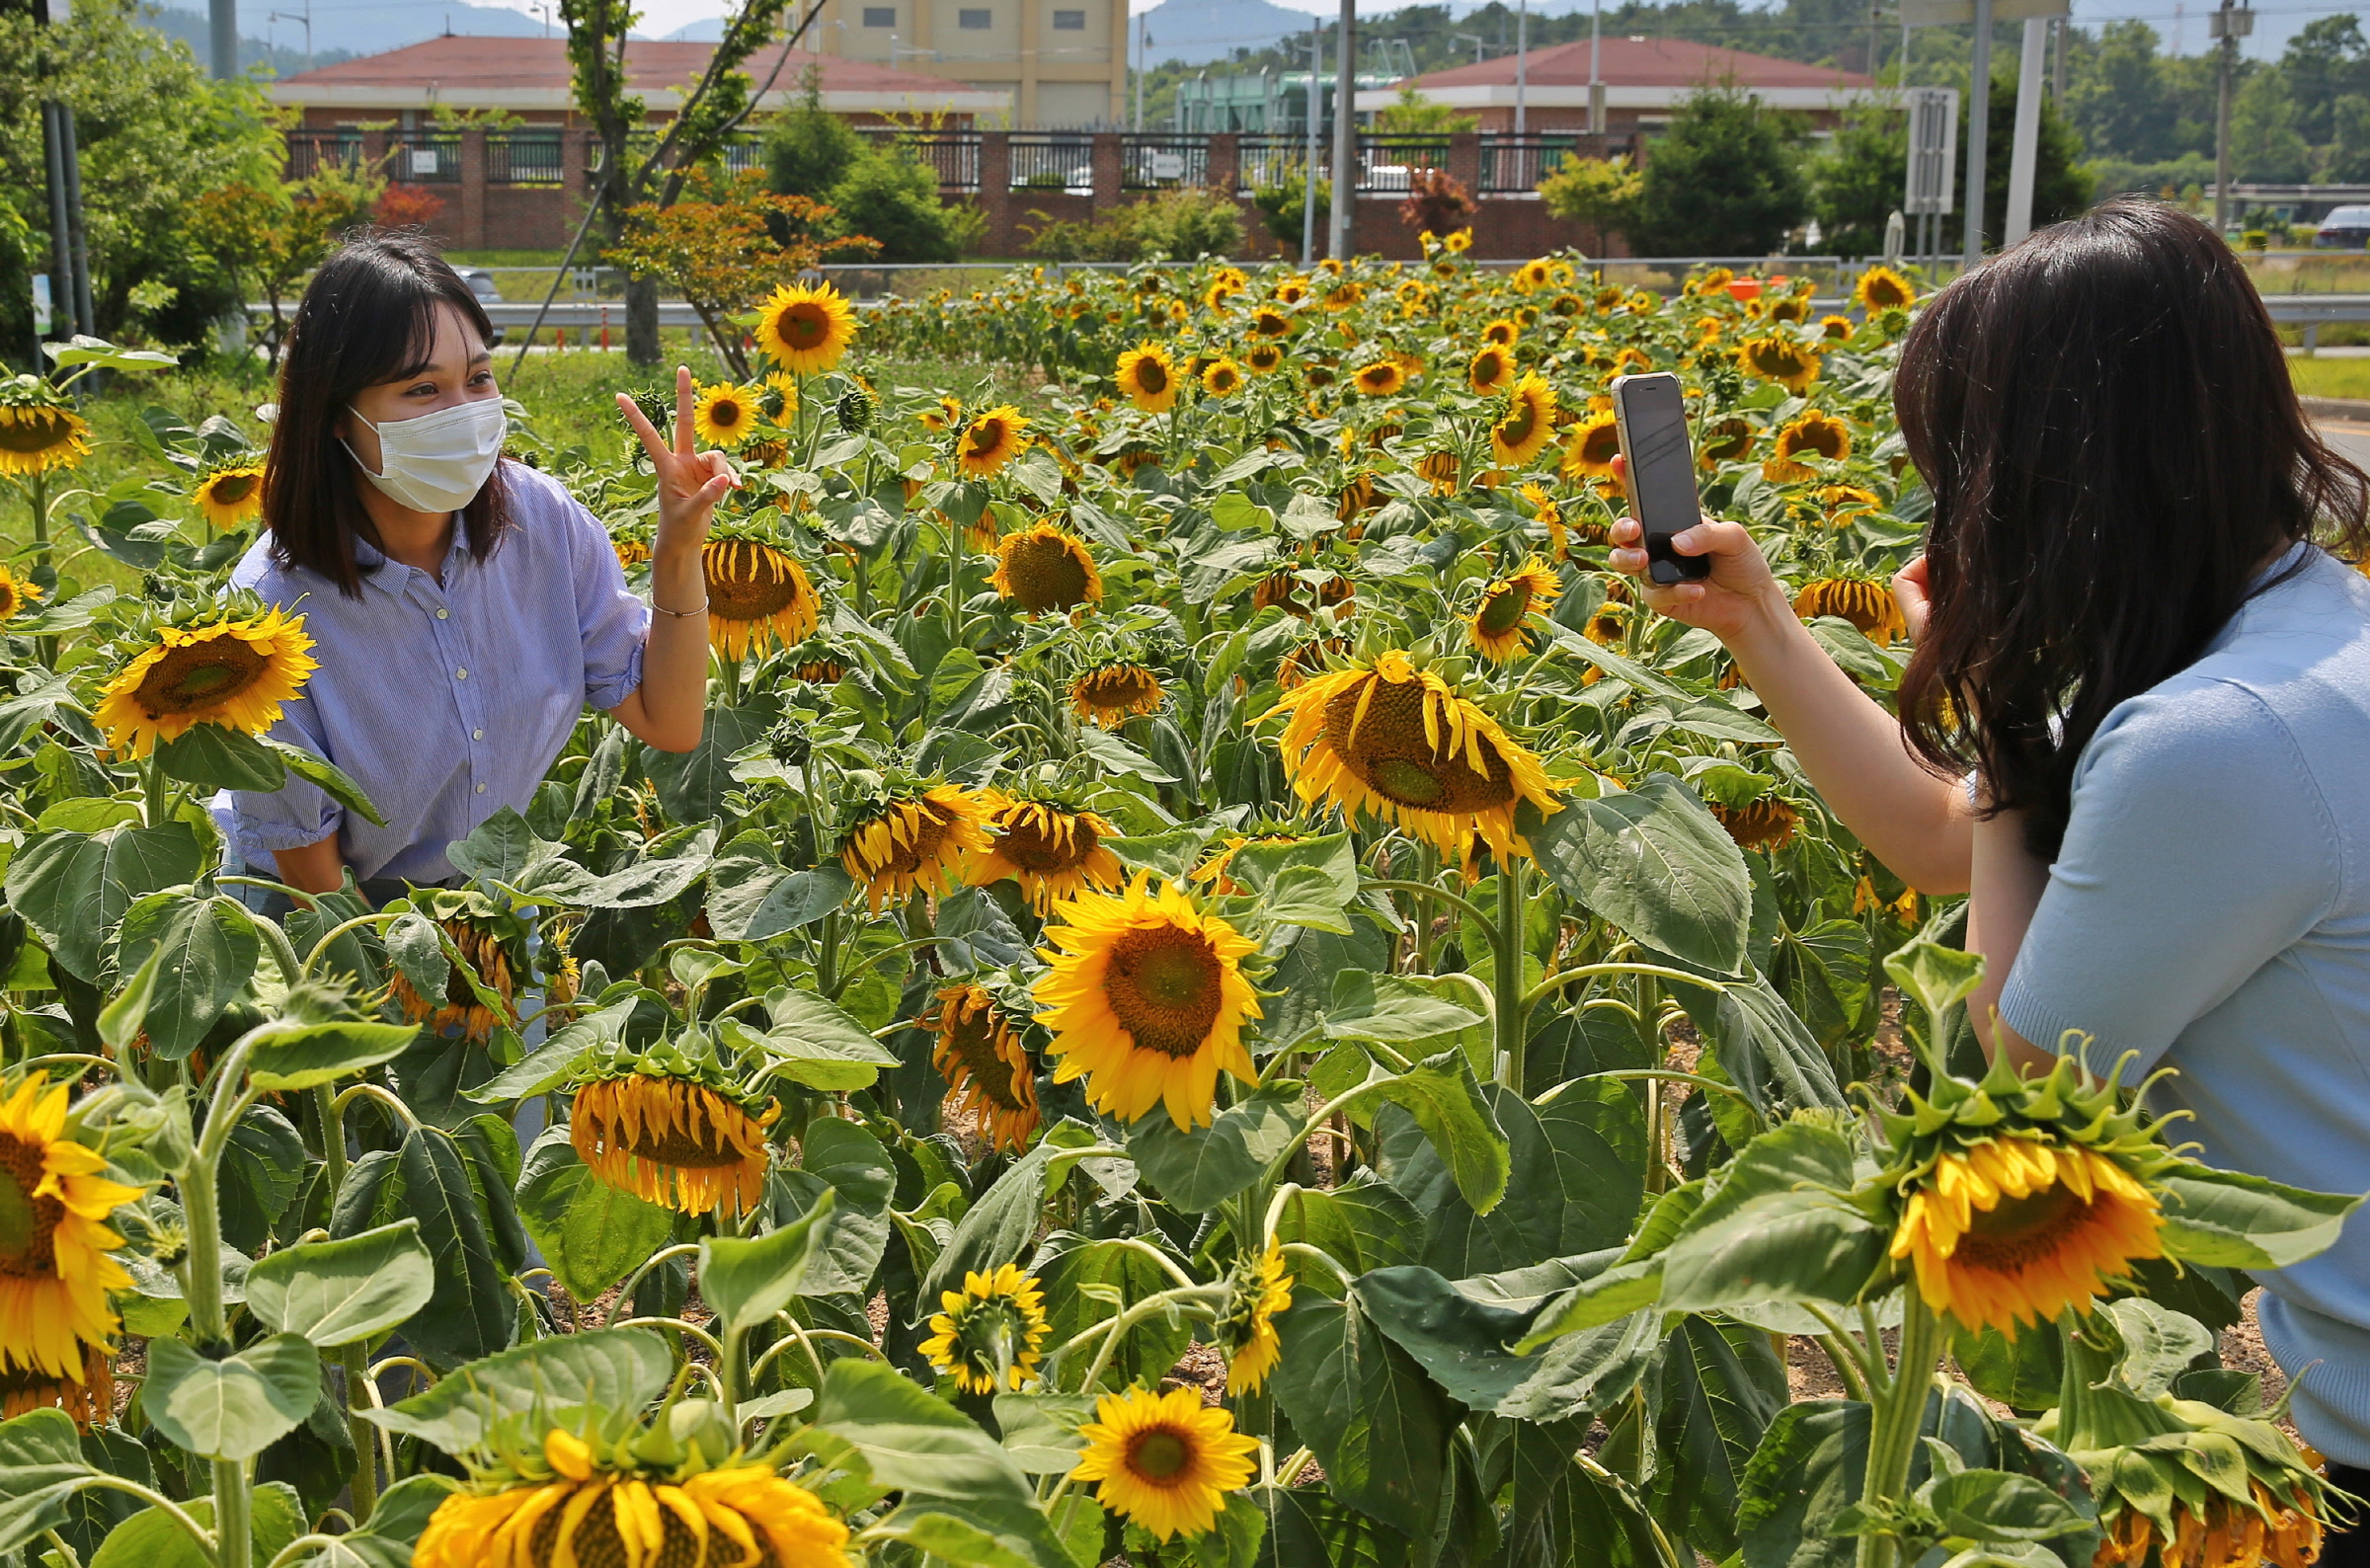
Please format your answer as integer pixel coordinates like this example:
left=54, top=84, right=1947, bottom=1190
left=230, top=462, right=650, bottom=884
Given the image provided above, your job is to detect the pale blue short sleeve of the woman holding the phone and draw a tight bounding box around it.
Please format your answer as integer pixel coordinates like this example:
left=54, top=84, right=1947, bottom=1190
left=2001, top=682, right=2344, bottom=1073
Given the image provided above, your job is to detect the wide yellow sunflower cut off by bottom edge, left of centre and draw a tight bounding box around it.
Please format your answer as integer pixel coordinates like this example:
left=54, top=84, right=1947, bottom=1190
left=413, top=1428, right=848, bottom=1568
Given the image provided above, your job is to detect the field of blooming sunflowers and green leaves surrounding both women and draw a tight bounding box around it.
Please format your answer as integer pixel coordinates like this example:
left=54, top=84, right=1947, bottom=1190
left=0, top=244, right=2356, bottom=1568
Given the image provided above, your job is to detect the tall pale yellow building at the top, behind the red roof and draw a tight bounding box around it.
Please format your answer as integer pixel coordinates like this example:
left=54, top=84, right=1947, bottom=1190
left=806, top=0, right=1131, bottom=130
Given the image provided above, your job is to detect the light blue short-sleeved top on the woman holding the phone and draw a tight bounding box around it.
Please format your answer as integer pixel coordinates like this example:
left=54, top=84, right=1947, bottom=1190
left=2001, top=545, right=2370, bottom=1466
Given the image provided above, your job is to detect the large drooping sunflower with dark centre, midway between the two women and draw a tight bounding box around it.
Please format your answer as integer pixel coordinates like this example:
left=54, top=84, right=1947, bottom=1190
left=1261, top=652, right=1562, bottom=857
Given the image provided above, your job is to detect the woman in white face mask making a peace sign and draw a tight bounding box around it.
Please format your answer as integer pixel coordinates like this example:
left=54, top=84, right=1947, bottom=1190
left=227, top=234, right=735, bottom=902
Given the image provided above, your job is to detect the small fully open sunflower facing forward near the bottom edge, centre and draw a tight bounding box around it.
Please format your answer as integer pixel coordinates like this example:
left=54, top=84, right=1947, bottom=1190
left=1068, top=1388, right=1258, bottom=1544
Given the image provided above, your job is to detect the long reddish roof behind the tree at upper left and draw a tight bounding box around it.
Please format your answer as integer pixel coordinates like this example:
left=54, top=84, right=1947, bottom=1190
left=275, top=38, right=967, bottom=100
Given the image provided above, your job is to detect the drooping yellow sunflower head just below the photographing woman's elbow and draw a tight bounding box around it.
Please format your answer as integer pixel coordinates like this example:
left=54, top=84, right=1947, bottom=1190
left=1889, top=1135, right=2164, bottom=1336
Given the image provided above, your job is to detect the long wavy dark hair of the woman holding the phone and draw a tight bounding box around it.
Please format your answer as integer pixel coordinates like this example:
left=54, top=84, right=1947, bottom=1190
left=1894, top=198, right=2370, bottom=860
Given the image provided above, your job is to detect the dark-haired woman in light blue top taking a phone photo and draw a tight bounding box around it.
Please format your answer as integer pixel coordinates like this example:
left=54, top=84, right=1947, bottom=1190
left=1612, top=201, right=2370, bottom=1563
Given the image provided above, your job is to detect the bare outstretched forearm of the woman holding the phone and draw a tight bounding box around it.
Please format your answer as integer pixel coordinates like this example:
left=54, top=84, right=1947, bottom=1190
left=1728, top=594, right=1972, bottom=893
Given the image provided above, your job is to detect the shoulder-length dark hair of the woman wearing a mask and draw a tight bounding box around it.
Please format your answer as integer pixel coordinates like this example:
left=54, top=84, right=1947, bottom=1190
left=263, top=230, right=510, bottom=599
